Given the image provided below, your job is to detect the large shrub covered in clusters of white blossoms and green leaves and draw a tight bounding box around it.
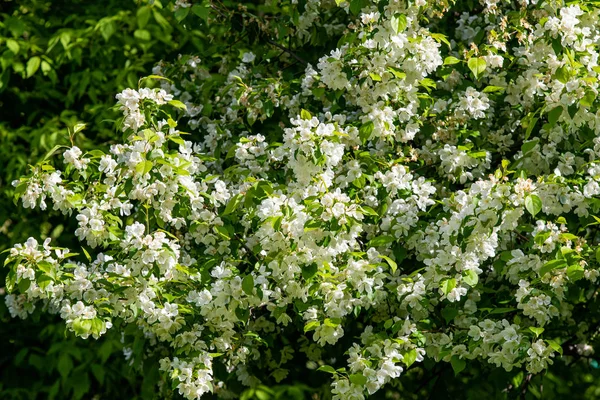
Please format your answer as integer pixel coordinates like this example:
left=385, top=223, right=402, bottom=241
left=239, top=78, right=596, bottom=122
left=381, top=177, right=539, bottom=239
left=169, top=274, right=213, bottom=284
left=6, top=0, right=600, bottom=399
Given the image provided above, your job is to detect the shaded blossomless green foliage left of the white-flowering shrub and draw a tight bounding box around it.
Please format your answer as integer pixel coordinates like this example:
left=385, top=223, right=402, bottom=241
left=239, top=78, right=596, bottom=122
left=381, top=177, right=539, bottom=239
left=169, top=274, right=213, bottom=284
left=0, top=0, right=197, bottom=399
